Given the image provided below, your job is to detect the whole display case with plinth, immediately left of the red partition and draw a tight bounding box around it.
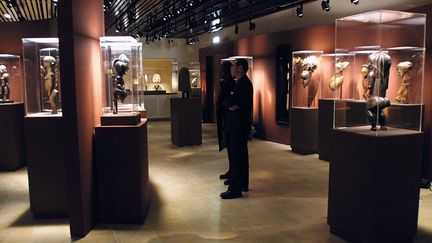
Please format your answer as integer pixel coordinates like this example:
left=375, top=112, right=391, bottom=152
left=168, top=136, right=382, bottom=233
left=22, top=38, right=69, bottom=217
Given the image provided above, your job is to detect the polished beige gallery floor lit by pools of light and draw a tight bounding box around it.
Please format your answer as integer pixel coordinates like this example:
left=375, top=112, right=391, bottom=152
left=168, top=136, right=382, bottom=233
left=0, top=121, right=432, bottom=243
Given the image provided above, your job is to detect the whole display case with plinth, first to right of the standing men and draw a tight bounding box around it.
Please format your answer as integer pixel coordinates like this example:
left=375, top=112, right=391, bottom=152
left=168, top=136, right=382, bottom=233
left=290, top=50, right=323, bottom=154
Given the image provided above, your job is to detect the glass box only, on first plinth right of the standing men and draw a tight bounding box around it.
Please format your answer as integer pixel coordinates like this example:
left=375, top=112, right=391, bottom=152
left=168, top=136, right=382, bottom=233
left=291, top=50, right=323, bottom=108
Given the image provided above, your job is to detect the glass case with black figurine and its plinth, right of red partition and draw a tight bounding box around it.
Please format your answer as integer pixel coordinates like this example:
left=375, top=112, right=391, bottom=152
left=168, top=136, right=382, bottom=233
left=94, top=36, right=149, bottom=223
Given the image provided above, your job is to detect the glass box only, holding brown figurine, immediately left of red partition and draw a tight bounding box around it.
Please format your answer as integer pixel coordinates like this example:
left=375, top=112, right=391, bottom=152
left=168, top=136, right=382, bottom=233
left=22, top=38, right=62, bottom=116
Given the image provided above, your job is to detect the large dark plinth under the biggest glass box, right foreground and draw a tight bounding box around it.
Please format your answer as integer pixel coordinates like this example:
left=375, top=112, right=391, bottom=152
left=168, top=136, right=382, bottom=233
left=327, top=126, right=423, bottom=242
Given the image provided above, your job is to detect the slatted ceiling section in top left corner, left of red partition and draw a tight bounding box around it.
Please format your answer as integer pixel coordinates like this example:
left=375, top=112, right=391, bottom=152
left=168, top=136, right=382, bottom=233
left=0, top=0, right=58, bottom=22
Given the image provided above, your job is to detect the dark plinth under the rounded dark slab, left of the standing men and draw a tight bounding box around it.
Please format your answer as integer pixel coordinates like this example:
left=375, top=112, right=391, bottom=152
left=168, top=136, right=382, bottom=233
left=171, top=98, right=202, bottom=146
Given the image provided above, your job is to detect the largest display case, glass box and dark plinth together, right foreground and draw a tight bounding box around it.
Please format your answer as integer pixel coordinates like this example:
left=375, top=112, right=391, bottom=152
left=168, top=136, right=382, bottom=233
left=328, top=10, right=426, bottom=242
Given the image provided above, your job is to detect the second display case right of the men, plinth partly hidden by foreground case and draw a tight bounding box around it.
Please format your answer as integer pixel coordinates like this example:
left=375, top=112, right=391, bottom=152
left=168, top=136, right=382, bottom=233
left=318, top=50, right=355, bottom=161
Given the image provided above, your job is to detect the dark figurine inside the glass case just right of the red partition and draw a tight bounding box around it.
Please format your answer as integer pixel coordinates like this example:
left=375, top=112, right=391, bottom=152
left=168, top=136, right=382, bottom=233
left=112, top=54, right=129, bottom=114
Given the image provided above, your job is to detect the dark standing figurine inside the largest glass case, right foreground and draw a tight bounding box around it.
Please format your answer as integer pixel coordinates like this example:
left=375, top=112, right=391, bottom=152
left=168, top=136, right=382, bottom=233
left=367, top=51, right=391, bottom=131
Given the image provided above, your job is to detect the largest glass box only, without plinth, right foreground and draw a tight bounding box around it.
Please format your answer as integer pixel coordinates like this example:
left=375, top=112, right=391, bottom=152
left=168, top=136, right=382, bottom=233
left=334, top=10, right=426, bottom=134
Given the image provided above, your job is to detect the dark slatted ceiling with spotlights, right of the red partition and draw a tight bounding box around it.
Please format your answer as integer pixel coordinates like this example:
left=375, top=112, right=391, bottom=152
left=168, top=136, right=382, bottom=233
left=104, top=0, right=314, bottom=43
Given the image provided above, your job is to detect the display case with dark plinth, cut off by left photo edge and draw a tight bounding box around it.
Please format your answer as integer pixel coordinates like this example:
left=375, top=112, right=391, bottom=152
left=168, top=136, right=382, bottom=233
left=0, top=54, right=25, bottom=170
